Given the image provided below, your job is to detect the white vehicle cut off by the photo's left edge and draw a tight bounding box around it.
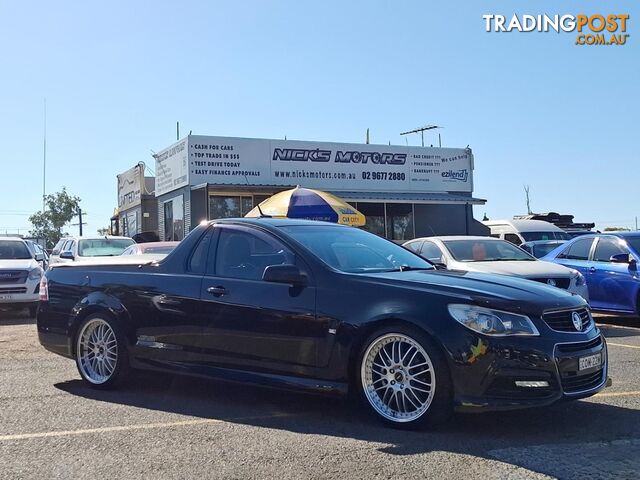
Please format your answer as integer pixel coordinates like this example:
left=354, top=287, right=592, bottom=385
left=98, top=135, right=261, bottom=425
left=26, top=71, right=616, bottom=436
left=0, top=237, right=43, bottom=317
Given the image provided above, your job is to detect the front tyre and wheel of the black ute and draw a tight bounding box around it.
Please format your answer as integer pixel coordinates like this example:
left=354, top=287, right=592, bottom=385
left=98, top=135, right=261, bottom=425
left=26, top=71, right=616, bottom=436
left=356, top=325, right=453, bottom=429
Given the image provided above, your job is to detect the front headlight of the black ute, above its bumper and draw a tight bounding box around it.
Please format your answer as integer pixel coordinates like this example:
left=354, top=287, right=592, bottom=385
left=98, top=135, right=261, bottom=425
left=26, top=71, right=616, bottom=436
left=449, top=304, right=540, bottom=336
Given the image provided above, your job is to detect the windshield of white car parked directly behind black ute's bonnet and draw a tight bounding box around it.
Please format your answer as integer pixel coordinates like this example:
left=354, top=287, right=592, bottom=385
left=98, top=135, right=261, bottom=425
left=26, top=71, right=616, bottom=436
left=442, top=239, right=535, bottom=262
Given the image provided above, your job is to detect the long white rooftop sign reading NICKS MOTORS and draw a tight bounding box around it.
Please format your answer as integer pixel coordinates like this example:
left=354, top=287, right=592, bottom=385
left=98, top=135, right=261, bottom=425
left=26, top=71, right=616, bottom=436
left=156, top=135, right=473, bottom=195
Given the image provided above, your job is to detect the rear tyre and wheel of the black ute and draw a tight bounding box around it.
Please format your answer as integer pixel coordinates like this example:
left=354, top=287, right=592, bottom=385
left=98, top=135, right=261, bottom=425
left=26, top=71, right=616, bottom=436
left=75, top=315, right=130, bottom=390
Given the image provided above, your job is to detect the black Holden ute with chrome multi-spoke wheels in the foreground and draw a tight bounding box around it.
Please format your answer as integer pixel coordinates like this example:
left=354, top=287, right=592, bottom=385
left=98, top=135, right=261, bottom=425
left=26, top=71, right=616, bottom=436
left=38, top=218, right=607, bottom=426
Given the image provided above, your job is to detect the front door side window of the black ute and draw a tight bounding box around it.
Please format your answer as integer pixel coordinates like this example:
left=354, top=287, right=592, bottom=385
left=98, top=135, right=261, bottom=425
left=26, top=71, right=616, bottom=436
left=215, top=228, right=295, bottom=280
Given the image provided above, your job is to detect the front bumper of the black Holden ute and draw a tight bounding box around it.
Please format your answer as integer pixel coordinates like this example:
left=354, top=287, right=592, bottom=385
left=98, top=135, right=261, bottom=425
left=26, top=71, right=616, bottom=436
left=442, top=326, right=608, bottom=412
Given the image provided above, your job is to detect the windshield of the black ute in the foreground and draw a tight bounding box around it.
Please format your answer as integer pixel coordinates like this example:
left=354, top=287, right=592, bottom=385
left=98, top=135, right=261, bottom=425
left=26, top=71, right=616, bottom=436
left=280, top=224, right=434, bottom=273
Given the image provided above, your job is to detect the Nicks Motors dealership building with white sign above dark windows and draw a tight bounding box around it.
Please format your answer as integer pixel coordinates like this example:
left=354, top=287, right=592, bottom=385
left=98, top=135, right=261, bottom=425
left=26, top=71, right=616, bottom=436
left=154, top=135, right=487, bottom=241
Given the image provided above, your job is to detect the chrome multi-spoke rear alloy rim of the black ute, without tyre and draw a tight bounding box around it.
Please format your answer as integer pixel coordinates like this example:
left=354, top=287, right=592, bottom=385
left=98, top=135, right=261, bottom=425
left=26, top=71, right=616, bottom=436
left=76, top=318, right=118, bottom=385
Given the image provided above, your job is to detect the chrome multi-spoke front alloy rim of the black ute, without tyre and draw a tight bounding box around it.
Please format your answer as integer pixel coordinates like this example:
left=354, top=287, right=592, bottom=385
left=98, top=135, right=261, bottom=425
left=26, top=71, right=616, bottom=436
left=360, top=333, right=436, bottom=423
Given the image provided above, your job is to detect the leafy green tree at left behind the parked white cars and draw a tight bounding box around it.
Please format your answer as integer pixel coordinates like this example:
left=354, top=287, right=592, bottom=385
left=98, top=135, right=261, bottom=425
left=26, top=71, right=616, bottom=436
left=29, top=187, right=80, bottom=248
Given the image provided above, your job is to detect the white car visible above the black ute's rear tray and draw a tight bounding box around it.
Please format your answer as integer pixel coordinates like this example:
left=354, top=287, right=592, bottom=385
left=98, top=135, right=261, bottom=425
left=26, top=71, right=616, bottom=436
left=49, top=235, right=135, bottom=265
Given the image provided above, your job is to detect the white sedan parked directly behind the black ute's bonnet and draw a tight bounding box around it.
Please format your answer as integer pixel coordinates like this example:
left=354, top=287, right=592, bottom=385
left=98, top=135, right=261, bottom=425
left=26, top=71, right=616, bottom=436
left=404, top=236, right=589, bottom=301
